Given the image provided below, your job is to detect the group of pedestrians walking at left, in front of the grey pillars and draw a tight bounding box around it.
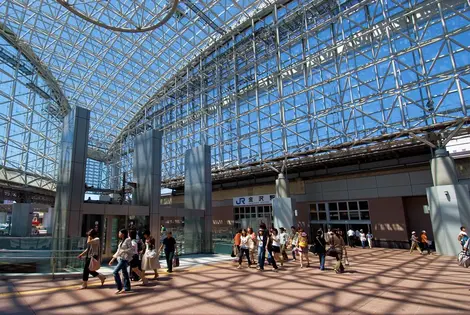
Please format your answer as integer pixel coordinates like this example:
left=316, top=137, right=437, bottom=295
left=78, top=229, right=176, bottom=294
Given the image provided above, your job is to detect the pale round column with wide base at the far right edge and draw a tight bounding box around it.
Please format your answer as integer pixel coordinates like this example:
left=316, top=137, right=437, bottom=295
left=426, top=148, right=470, bottom=256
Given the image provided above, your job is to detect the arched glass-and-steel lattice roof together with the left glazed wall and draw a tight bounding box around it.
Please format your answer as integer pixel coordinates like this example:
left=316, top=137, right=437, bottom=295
left=0, top=0, right=271, bottom=190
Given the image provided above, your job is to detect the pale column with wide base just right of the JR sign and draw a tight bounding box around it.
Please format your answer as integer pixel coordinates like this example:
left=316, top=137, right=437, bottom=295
left=272, top=173, right=296, bottom=230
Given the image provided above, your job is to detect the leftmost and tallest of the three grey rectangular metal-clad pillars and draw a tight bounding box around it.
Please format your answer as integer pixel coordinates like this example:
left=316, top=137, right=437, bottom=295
left=53, top=107, right=90, bottom=250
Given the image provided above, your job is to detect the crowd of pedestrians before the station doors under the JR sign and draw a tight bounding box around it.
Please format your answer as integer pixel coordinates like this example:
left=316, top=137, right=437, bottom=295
left=232, top=223, right=346, bottom=273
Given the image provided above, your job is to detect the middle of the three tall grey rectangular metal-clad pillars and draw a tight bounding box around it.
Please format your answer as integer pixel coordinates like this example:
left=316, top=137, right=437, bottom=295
left=133, top=129, right=162, bottom=244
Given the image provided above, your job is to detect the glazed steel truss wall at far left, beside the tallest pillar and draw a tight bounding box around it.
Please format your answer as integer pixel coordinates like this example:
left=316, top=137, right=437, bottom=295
left=0, top=25, right=63, bottom=193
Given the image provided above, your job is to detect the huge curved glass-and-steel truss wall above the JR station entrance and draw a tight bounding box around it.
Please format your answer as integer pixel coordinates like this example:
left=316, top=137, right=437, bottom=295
left=111, top=0, right=470, bottom=187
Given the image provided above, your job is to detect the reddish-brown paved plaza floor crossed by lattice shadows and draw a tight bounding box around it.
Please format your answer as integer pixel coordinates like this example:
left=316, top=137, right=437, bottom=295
left=0, top=248, right=470, bottom=314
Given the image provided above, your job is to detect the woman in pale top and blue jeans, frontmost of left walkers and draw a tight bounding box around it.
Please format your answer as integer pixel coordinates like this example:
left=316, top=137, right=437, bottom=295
left=109, top=229, right=133, bottom=294
